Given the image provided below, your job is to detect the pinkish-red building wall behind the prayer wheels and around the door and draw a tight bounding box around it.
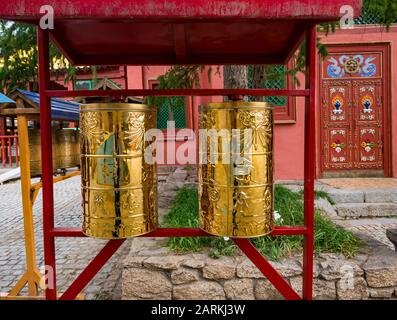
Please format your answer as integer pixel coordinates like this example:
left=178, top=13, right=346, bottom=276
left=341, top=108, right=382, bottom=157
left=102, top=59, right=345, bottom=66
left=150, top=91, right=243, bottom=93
left=53, top=26, right=397, bottom=180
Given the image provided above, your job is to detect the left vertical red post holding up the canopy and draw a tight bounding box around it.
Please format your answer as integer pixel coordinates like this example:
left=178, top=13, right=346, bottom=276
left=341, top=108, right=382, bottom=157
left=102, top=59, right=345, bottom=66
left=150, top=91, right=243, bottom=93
left=37, top=27, right=57, bottom=300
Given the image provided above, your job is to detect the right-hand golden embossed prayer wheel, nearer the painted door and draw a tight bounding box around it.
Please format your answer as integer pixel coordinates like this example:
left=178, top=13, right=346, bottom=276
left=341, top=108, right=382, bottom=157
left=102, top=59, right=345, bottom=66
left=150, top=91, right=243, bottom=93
left=199, top=101, right=273, bottom=238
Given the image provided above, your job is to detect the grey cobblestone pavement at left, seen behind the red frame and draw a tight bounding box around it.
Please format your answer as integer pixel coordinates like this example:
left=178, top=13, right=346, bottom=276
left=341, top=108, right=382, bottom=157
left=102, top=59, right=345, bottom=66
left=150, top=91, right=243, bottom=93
left=0, top=176, right=130, bottom=299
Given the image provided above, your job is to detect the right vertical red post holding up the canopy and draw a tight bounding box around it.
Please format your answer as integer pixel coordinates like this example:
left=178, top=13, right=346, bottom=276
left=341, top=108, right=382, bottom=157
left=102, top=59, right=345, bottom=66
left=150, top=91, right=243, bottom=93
left=302, top=26, right=316, bottom=300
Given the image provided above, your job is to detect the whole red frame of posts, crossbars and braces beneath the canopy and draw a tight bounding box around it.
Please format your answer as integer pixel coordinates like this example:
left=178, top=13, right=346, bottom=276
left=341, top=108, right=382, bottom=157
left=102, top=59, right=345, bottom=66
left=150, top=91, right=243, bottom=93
left=37, top=25, right=316, bottom=300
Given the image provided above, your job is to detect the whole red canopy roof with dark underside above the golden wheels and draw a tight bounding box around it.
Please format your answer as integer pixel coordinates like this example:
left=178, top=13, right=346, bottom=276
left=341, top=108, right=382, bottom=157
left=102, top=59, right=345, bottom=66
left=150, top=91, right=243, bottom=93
left=0, top=0, right=362, bottom=65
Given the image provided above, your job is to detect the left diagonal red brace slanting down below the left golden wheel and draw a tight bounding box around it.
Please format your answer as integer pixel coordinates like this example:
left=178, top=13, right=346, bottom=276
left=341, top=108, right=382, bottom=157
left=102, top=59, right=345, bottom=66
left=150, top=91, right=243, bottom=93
left=60, top=239, right=125, bottom=300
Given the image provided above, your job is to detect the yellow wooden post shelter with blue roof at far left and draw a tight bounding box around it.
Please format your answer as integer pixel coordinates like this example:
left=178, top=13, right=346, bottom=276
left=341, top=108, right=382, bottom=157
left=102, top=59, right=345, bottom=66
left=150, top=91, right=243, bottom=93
left=0, top=89, right=80, bottom=299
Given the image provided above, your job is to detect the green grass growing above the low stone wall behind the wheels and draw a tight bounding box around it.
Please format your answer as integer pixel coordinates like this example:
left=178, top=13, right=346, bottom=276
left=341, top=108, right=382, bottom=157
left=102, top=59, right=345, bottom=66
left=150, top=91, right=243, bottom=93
left=165, top=185, right=360, bottom=260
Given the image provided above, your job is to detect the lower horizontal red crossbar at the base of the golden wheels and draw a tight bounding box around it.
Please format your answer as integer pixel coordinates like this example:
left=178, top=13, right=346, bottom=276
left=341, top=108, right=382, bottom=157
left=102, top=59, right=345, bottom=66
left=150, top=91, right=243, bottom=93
left=50, top=226, right=307, bottom=238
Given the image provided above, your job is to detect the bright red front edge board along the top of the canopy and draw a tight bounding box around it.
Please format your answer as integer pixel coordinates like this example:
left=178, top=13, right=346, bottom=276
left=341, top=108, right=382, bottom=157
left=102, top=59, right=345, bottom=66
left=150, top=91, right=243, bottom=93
left=0, top=0, right=362, bottom=21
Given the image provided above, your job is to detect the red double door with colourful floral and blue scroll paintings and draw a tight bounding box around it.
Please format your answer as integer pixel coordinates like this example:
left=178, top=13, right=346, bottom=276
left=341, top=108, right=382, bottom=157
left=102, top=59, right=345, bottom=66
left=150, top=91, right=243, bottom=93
left=320, top=45, right=389, bottom=177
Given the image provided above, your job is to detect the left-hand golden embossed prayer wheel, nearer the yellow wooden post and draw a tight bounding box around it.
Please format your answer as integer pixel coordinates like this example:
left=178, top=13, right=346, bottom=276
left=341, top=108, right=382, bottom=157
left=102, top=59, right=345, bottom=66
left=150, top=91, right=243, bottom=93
left=80, top=103, right=157, bottom=239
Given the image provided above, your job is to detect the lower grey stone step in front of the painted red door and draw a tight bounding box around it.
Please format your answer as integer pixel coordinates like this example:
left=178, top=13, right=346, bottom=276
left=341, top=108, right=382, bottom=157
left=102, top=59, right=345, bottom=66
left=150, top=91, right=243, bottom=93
left=335, top=202, right=397, bottom=218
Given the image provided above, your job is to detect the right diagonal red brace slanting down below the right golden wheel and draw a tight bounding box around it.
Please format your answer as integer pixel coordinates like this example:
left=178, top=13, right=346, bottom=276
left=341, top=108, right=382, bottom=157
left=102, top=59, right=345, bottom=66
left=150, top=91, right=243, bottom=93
left=233, top=239, right=301, bottom=300
